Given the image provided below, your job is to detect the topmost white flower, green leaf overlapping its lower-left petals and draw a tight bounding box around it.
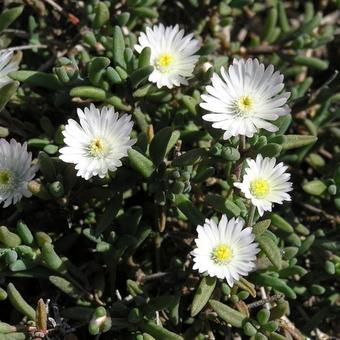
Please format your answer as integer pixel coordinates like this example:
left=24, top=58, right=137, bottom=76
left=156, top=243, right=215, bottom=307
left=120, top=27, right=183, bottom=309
left=135, top=24, right=200, bottom=89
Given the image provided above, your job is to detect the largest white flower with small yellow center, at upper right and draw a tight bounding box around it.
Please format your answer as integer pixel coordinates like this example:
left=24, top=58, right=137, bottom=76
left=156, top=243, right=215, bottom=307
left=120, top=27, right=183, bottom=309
left=200, top=59, right=290, bottom=139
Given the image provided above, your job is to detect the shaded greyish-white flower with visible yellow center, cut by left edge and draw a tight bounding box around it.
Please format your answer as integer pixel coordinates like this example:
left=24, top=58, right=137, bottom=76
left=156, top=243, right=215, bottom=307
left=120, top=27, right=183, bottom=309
left=0, top=138, right=38, bottom=208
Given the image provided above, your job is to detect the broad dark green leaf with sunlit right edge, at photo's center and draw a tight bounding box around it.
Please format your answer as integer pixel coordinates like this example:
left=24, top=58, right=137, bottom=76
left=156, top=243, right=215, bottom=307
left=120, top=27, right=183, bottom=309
left=149, top=127, right=179, bottom=166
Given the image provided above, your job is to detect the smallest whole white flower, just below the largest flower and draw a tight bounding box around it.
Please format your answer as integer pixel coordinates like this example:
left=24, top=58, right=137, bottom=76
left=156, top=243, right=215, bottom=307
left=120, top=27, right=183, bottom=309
left=234, top=155, right=293, bottom=216
